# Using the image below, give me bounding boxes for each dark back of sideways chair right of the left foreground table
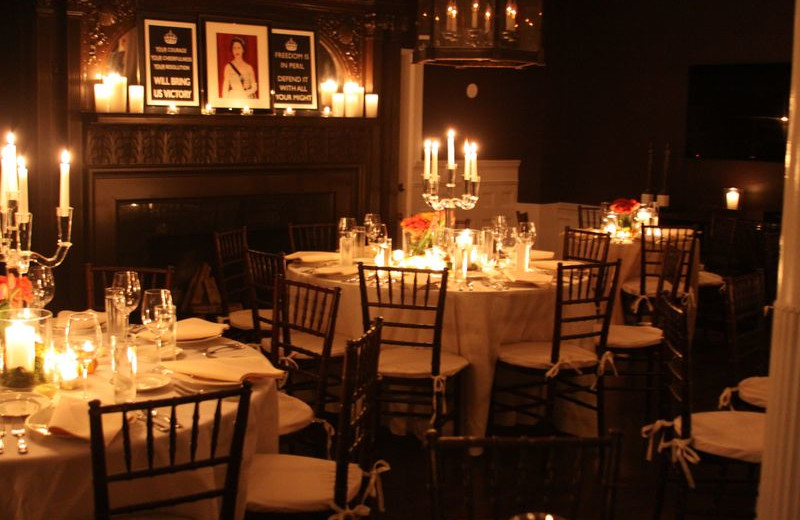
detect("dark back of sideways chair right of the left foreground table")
[334,318,383,507]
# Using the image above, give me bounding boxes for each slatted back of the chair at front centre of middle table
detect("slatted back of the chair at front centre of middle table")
[358,263,448,375]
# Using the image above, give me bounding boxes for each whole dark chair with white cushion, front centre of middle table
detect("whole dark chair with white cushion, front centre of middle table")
[358,262,469,432]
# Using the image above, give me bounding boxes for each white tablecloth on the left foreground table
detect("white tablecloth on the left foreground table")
[0,341,278,520]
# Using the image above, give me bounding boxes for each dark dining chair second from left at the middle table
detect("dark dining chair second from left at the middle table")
[241,249,286,349]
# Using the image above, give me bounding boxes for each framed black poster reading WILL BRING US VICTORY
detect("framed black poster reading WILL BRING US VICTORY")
[144,19,200,107]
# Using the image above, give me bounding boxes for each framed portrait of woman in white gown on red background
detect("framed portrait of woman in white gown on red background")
[204,20,271,108]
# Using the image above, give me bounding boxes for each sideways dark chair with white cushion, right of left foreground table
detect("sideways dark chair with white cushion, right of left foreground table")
[247,319,389,518]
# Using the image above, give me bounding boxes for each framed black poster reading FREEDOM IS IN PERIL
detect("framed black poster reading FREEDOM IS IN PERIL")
[270,29,317,109]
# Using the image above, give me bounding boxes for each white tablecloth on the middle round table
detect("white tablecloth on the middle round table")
[287,266,555,435]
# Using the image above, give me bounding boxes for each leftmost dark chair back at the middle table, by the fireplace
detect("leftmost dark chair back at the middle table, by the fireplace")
[214,226,247,315]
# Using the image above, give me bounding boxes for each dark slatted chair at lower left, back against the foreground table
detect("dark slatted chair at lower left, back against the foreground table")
[89,382,251,520]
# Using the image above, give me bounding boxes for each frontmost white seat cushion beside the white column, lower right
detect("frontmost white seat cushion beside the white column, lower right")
[674,411,766,463]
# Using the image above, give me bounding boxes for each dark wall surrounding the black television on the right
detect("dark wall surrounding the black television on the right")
[424,0,794,215]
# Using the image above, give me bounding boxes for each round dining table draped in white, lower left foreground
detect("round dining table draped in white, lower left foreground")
[0,338,278,520]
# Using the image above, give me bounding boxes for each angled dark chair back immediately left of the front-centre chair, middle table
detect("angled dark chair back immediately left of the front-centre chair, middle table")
[270,275,342,415]
